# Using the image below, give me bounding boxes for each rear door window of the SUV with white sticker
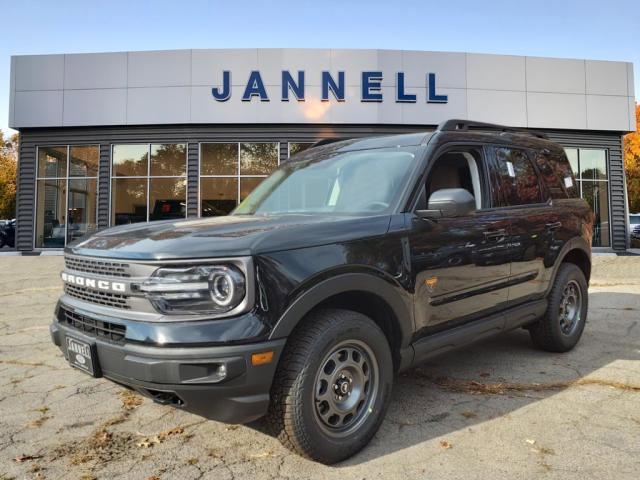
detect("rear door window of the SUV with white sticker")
[492,147,542,207]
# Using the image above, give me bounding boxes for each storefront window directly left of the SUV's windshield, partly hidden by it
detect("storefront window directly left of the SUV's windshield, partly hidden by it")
[200,142,280,217]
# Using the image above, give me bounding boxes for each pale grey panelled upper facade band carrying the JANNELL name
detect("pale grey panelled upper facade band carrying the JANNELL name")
[9,48,635,131]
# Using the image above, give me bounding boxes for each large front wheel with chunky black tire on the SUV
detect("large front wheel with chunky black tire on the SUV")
[266,309,394,464]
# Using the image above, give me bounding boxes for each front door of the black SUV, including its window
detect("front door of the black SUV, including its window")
[409,146,510,336]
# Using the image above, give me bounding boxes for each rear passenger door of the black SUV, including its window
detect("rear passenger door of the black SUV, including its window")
[489,146,561,305]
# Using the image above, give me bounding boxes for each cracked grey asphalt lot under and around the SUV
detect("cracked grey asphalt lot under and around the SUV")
[0,257,640,480]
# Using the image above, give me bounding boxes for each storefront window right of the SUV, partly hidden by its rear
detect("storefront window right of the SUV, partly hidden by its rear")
[565,148,611,247]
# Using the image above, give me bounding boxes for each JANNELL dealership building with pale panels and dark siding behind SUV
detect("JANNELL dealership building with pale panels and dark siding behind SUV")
[9,49,636,253]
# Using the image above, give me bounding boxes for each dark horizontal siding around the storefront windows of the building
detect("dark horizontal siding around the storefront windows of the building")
[17,124,627,250]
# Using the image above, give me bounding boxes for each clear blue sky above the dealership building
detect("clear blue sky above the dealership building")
[0,0,640,132]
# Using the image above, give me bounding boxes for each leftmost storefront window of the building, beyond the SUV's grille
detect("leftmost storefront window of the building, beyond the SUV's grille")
[35,145,100,248]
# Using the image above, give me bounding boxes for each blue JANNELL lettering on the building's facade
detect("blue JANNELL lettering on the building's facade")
[211,70,449,103]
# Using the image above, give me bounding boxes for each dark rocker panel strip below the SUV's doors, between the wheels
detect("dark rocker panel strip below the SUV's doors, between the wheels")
[412,299,547,365]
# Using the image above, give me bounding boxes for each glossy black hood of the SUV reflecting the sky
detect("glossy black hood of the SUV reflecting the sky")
[65,215,391,260]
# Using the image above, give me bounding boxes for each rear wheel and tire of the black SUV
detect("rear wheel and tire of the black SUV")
[529,263,589,352]
